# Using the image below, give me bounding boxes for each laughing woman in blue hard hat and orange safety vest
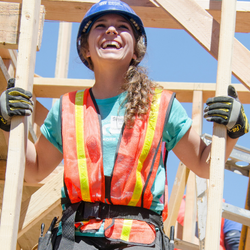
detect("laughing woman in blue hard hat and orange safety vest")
[1,0,248,250]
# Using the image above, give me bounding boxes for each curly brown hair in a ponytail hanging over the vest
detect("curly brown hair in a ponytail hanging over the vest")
[80,32,162,128]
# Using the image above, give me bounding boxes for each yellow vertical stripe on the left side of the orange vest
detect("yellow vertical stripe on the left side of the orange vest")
[75,91,91,201]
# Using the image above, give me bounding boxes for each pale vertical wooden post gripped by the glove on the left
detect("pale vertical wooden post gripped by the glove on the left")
[0,0,41,250]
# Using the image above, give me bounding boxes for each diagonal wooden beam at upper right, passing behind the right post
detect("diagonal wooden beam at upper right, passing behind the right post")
[156,0,250,90]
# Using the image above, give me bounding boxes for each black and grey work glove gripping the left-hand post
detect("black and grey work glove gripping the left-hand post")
[0,78,33,131]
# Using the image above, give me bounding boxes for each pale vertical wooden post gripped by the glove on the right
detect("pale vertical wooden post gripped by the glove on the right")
[205,0,236,250]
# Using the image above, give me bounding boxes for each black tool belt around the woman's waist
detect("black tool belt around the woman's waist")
[38,201,172,250]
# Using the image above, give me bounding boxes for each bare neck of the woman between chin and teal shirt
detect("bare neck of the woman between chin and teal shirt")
[92,62,127,99]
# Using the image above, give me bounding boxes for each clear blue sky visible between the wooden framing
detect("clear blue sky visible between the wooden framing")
[35,6,250,207]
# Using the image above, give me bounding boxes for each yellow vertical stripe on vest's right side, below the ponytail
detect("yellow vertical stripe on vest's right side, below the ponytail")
[128,89,162,206]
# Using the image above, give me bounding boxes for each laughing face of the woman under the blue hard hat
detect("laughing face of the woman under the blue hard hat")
[87,14,136,68]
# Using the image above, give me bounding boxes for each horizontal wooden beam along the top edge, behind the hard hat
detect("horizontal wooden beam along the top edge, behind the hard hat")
[1,0,250,33]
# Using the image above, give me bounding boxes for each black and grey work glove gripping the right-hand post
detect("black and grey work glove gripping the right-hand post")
[204,85,249,138]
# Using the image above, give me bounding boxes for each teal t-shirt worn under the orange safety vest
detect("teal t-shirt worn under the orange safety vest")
[41,92,192,236]
